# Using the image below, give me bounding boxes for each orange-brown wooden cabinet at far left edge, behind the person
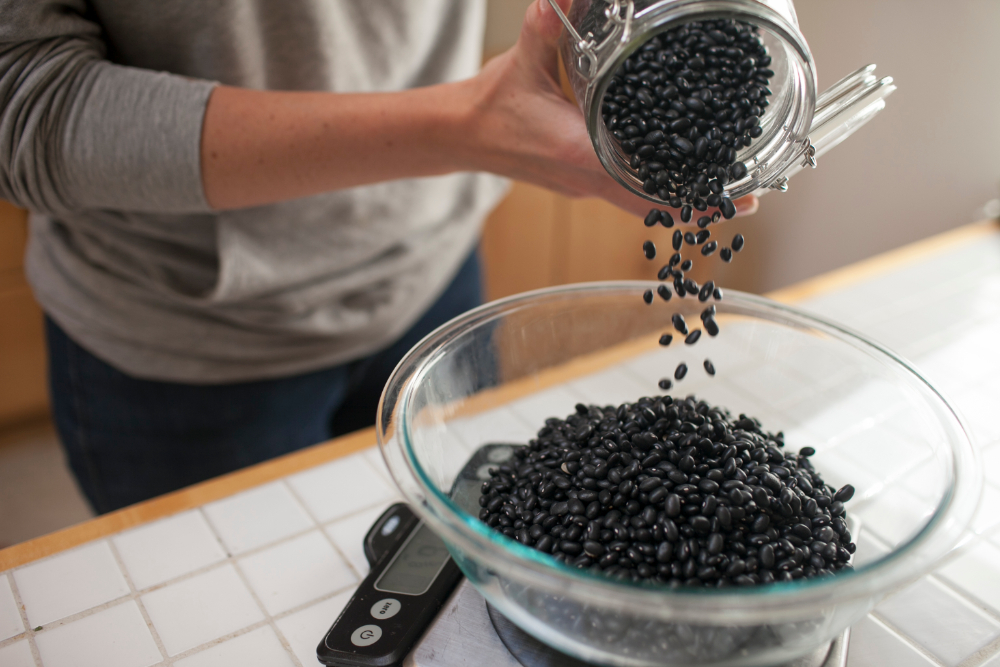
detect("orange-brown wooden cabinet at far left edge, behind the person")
[0,201,48,428]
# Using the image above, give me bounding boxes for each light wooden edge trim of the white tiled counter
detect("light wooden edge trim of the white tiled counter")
[0,221,1000,572]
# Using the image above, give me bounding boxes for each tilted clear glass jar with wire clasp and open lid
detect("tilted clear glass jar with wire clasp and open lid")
[549,0,896,205]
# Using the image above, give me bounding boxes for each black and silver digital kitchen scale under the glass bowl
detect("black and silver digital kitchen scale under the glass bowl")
[316,445,850,667]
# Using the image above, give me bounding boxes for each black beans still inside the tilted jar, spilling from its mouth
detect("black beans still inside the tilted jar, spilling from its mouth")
[601,19,774,222]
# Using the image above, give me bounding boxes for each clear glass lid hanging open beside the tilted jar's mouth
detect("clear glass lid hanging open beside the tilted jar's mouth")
[758,65,896,194]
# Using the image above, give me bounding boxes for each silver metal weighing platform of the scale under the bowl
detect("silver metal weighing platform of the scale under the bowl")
[403,579,850,667]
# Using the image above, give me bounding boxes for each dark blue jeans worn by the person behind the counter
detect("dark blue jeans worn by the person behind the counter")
[45,253,482,513]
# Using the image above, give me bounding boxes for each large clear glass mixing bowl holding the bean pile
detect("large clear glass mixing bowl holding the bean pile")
[378,282,980,666]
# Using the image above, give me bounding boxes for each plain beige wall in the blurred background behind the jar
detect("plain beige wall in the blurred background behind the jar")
[487,0,1000,291]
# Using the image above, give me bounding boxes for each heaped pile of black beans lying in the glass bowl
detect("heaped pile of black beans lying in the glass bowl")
[479,396,855,587]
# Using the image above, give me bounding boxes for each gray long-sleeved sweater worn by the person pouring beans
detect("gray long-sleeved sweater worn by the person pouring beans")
[0,0,505,383]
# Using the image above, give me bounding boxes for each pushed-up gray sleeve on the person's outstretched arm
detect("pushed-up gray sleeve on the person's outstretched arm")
[0,0,214,215]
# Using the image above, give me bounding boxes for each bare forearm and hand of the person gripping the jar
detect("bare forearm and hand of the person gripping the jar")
[201,0,756,215]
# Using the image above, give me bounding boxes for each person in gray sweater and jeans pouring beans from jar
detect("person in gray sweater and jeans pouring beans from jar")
[0,0,755,512]
